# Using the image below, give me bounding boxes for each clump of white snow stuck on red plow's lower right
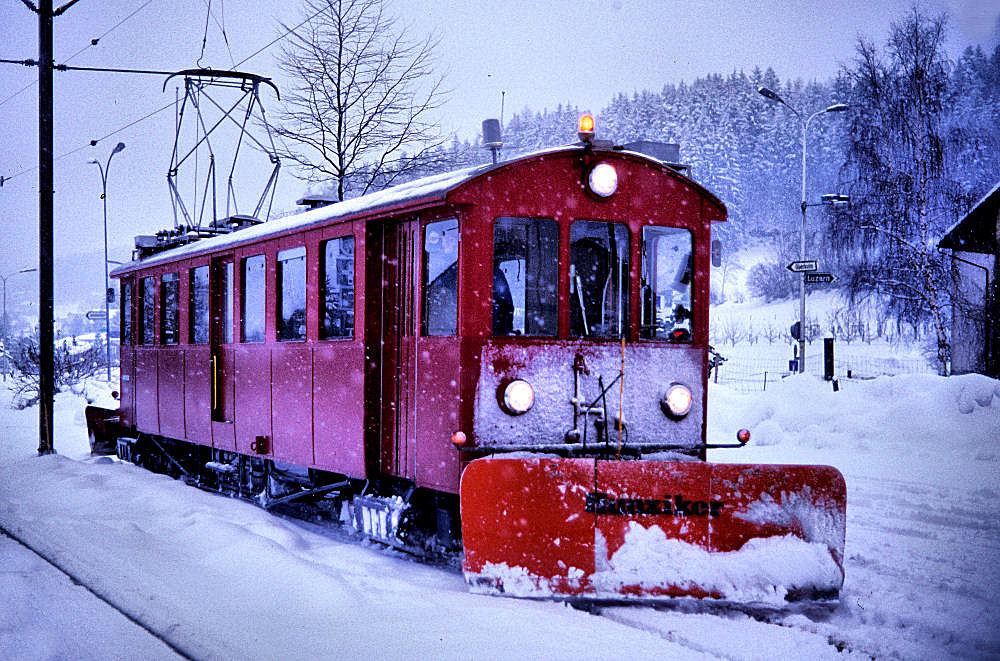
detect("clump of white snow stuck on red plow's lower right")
[592,521,843,605]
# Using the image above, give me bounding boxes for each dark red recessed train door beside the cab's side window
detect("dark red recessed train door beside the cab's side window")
[366,221,419,479]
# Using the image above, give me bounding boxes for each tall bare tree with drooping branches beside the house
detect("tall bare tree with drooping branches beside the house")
[830,8,967,374]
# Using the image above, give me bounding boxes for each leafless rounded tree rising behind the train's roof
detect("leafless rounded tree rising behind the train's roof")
[276,0,445,200]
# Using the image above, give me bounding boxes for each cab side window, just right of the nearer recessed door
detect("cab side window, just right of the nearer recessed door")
[422,218,458,335]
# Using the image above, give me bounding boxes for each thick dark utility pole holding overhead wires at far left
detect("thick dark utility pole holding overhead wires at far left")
[21,0,79,454]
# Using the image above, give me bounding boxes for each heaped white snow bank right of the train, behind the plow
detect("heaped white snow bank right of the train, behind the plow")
[708,374,1000,486]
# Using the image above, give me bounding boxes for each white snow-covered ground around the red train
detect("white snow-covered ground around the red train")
[0,366,1000,659]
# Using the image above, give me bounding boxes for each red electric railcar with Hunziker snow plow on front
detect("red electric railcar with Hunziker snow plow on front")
[103,124,844,598]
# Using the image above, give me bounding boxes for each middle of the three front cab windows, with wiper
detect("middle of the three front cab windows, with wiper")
[569,220,629,337]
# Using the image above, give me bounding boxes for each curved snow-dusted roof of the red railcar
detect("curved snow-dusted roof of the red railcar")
[110,145,725,276]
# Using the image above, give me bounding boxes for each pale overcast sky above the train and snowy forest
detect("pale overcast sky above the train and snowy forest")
[0,0,1000,314]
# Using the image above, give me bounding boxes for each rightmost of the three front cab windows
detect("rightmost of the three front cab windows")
[641,227,693,342]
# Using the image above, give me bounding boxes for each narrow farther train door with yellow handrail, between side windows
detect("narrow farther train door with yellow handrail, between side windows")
[209,255,236,450]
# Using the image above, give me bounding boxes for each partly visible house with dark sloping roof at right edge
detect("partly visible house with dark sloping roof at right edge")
[938,184,1000,378]
